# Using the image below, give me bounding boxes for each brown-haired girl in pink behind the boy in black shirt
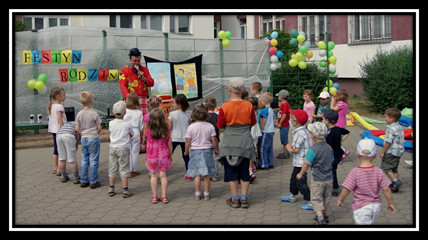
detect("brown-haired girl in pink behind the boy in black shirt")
[330,88,349,163]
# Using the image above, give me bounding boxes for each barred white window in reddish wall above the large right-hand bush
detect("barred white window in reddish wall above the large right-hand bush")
[348,15,391,44]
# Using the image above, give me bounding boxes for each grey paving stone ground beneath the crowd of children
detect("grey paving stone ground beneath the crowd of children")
[10,123,419,231]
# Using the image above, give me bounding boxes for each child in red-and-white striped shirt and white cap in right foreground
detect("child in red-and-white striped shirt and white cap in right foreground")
[337,138,395,225]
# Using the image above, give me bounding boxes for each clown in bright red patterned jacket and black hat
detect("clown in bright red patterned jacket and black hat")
[119,48,154,153]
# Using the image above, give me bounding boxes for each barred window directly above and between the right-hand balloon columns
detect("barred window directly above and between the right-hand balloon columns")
[299,15,331,46]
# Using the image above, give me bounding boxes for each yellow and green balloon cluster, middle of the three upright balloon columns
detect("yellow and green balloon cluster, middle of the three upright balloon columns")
[288,29,314,69]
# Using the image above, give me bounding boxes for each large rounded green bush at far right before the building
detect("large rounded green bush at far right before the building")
[358,45,415,113]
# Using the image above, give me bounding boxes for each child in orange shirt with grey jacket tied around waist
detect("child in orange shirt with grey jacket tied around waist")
[217,77,257,208]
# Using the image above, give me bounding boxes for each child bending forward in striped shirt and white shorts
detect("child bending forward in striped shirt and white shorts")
[56,122,80,184]
